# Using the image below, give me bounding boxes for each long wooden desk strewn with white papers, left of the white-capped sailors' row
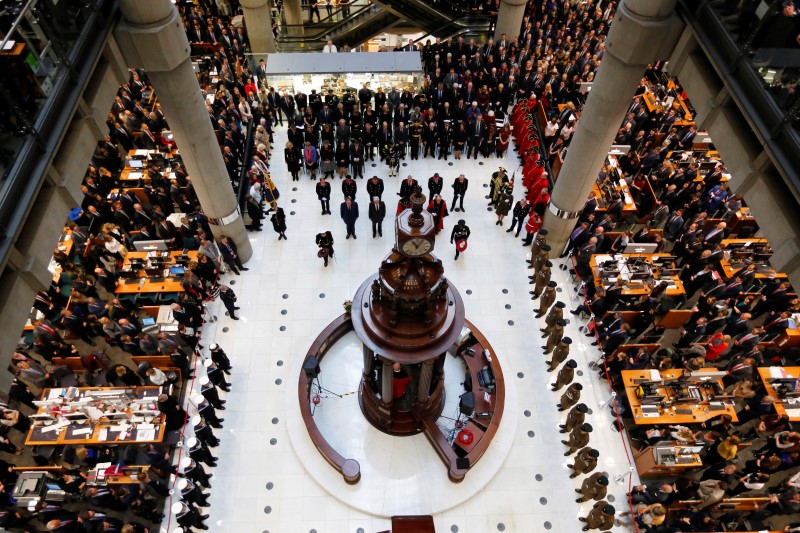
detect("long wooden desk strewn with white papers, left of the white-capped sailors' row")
[25,386,166,446]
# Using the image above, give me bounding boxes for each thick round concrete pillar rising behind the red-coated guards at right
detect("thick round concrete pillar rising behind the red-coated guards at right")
[540,0,683,253]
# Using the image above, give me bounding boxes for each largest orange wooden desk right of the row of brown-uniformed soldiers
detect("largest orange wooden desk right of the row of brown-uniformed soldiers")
[622,368,739,425]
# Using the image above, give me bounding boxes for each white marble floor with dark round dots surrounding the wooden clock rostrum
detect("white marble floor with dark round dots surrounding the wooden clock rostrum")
[169,124,629,533]
